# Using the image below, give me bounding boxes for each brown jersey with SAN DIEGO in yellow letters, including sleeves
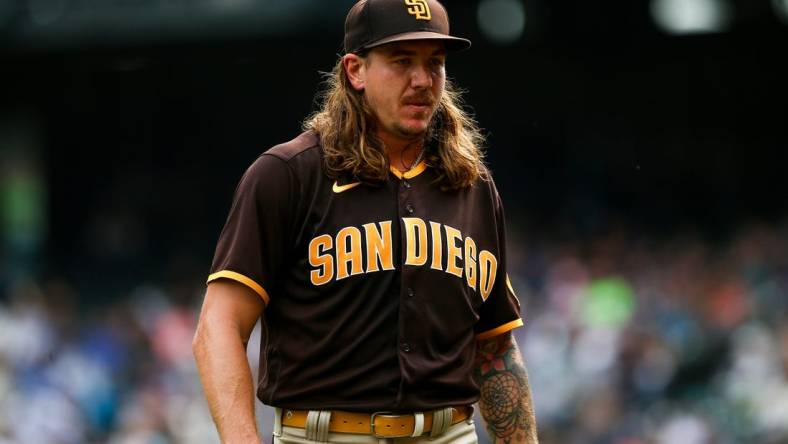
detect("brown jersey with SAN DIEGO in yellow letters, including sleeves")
[208,132,522,412]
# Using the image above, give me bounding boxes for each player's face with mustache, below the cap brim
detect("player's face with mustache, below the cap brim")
[343,40,446,140]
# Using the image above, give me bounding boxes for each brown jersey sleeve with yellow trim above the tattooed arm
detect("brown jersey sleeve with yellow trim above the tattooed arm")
[474,179,523,339]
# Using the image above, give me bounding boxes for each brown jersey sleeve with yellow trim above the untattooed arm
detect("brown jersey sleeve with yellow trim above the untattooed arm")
[207,154,295,305]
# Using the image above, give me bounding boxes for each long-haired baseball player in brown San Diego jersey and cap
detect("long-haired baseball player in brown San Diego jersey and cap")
[194,0,536,443]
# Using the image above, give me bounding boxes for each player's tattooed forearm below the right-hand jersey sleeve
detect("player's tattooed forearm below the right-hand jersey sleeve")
[474,332,538,444]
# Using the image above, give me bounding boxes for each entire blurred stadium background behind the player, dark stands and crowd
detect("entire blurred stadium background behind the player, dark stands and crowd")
[0,0,788,444]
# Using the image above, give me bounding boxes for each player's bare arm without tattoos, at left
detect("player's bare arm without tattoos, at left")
[192,280,264,444]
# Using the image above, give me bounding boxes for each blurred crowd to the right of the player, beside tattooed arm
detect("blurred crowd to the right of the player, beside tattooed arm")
[513,224,788,444]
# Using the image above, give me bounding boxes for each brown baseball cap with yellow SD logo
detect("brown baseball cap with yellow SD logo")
[345,0,471,53]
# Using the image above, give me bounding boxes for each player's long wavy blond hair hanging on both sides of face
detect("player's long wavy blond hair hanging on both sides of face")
[303,58,487,190]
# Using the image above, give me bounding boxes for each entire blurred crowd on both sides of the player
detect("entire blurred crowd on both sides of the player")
[0,220,788,444]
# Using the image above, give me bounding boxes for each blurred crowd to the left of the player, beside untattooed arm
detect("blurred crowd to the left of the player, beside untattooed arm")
[0,281,218,444]
